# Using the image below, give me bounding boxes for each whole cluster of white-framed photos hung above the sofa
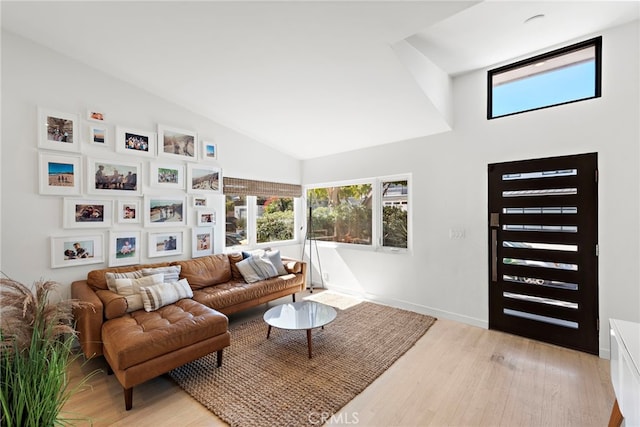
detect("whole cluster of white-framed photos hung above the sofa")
[37,107,222,268]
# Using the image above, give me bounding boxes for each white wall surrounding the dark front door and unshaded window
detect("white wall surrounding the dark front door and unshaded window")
[303,22,640,356]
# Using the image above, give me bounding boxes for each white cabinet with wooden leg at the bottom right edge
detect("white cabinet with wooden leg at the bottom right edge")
[609,319,640,427]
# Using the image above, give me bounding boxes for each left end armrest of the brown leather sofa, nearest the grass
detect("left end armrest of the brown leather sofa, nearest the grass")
[71,280,104,358]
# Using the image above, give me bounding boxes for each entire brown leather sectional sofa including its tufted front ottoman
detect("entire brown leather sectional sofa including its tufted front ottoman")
[71,253,307,410]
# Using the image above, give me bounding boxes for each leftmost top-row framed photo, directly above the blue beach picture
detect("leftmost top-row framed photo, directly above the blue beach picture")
[38,107,80,151]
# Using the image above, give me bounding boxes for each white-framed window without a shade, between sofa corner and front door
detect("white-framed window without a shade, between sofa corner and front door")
[307,176,409,250]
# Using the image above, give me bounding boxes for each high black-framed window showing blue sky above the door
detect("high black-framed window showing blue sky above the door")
[487,37,602,119]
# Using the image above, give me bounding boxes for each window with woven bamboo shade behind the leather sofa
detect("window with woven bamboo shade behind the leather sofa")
[224,177,302,251]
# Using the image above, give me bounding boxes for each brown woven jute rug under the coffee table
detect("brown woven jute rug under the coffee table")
[170,291,436,427]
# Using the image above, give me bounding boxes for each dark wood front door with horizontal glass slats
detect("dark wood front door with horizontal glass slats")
[488,153,599,354]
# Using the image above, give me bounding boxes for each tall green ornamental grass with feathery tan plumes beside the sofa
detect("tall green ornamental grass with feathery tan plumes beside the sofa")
[0,277,95,427]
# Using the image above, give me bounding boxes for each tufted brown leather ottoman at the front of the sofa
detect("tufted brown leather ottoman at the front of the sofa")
[102,299,230,410]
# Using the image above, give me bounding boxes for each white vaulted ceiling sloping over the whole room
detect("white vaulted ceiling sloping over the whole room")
[1,1,640,159]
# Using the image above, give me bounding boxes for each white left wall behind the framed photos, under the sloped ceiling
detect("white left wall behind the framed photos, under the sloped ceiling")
[0,32,301,297]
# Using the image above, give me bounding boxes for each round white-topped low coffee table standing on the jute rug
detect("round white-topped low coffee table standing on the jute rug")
[264,301,336,359]
